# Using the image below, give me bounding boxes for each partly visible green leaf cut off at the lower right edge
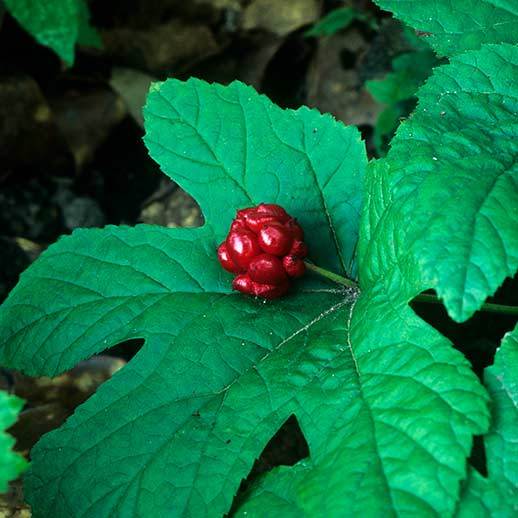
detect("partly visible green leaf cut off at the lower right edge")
[457,327,518,518]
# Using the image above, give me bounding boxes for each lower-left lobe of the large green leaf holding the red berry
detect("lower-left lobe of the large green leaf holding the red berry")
[26,286,345,517]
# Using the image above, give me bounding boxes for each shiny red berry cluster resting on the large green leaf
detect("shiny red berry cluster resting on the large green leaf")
[218,203,307,299]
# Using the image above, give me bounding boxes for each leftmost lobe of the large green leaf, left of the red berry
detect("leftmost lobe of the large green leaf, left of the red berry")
[0,225,230,376]
